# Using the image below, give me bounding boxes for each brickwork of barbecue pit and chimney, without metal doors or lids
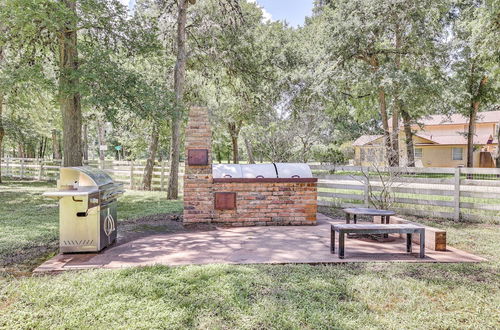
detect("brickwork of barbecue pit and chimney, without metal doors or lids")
[184,107,317,226]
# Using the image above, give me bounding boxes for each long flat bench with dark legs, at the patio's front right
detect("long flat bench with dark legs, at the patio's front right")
[330,224,425,259]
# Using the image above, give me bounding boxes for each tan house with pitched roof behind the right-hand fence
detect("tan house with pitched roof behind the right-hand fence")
[353,111,500,167]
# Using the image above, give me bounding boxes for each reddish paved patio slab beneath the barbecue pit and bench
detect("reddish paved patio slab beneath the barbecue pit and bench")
[35,214,486,273]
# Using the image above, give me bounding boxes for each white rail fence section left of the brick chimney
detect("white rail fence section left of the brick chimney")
[1,158,184,191]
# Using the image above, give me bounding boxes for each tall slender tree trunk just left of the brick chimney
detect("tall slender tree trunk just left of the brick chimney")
[167,0,188,199]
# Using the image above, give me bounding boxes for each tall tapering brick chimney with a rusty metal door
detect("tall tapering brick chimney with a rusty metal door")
[184,107,214,223]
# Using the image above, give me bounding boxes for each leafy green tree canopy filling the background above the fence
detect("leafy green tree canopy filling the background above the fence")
[0,0,500,184]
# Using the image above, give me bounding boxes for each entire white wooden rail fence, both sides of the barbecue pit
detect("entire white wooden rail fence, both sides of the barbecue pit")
[1,158,500,223]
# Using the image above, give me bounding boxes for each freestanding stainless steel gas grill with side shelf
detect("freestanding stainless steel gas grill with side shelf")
[43,166,124,253]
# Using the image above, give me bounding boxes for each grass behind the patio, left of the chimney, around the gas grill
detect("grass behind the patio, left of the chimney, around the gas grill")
[0,181,182,268]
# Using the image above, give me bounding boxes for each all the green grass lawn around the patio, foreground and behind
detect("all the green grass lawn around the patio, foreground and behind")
[0,182,500,329]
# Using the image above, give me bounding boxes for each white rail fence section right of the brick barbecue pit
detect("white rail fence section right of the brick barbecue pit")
[311,165,500,223]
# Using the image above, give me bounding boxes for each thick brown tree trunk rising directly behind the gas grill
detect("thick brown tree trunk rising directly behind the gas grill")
[59,0,82,166]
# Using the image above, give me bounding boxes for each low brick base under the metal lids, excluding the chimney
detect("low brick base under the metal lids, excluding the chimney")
[213,182,317,226]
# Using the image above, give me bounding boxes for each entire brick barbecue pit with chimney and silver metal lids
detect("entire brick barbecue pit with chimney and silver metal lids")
[184,107,317,226]
